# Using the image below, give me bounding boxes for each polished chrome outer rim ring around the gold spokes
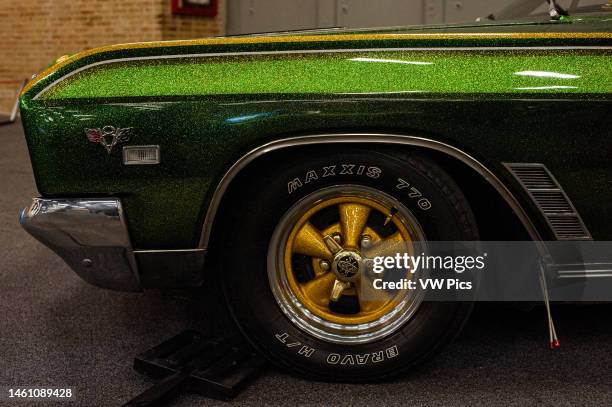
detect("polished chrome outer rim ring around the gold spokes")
[267,184,426,344]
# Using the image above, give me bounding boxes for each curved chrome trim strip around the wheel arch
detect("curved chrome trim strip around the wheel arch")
[198,133,548,252]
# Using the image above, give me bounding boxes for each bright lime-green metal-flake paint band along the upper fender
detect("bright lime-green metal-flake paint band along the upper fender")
[38,51,612,100]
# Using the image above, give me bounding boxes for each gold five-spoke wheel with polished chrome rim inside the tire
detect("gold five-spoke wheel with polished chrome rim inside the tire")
[268,185,425,343]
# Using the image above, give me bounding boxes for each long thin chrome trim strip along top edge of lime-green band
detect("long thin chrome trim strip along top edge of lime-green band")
[32,45,612,100]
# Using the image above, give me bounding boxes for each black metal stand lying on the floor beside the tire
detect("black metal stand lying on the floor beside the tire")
[124,331,265,407]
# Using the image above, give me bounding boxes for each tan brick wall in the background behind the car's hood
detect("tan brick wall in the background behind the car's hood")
[0,0,226,113]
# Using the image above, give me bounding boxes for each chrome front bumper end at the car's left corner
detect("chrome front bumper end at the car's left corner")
[19,198,141,291]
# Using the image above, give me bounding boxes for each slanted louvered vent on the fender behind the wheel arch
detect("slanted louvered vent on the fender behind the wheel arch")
[504,163,591,240]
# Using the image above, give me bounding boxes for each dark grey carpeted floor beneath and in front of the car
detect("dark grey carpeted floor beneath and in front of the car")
[0,122,612,406]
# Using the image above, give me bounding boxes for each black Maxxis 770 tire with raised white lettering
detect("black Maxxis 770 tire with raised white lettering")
[221,149,478,382]
